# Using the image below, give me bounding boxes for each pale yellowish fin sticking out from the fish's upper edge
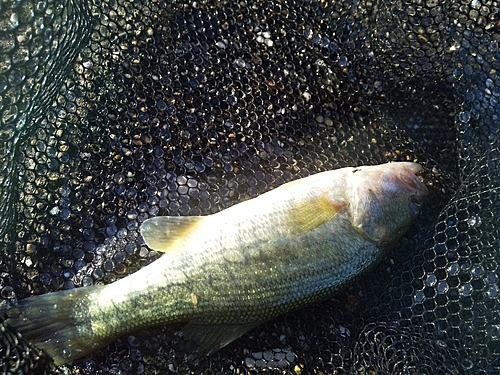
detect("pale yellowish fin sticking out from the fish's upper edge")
[141,216,206,252]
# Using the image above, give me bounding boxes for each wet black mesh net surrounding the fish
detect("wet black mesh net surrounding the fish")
[0,0,500,374]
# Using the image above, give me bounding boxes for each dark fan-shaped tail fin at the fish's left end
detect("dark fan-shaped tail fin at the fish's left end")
[0,286,111,366]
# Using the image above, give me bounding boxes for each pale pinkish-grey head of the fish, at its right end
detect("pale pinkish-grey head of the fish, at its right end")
[350,162,428,248]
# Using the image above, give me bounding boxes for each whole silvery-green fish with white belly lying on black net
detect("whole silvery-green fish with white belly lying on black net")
[0,162,428,365]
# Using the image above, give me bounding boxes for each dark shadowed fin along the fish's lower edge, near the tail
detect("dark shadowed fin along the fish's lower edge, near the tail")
[182,323,260,360]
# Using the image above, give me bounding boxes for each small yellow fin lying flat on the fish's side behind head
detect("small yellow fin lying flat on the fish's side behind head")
[286,193,349,235]
